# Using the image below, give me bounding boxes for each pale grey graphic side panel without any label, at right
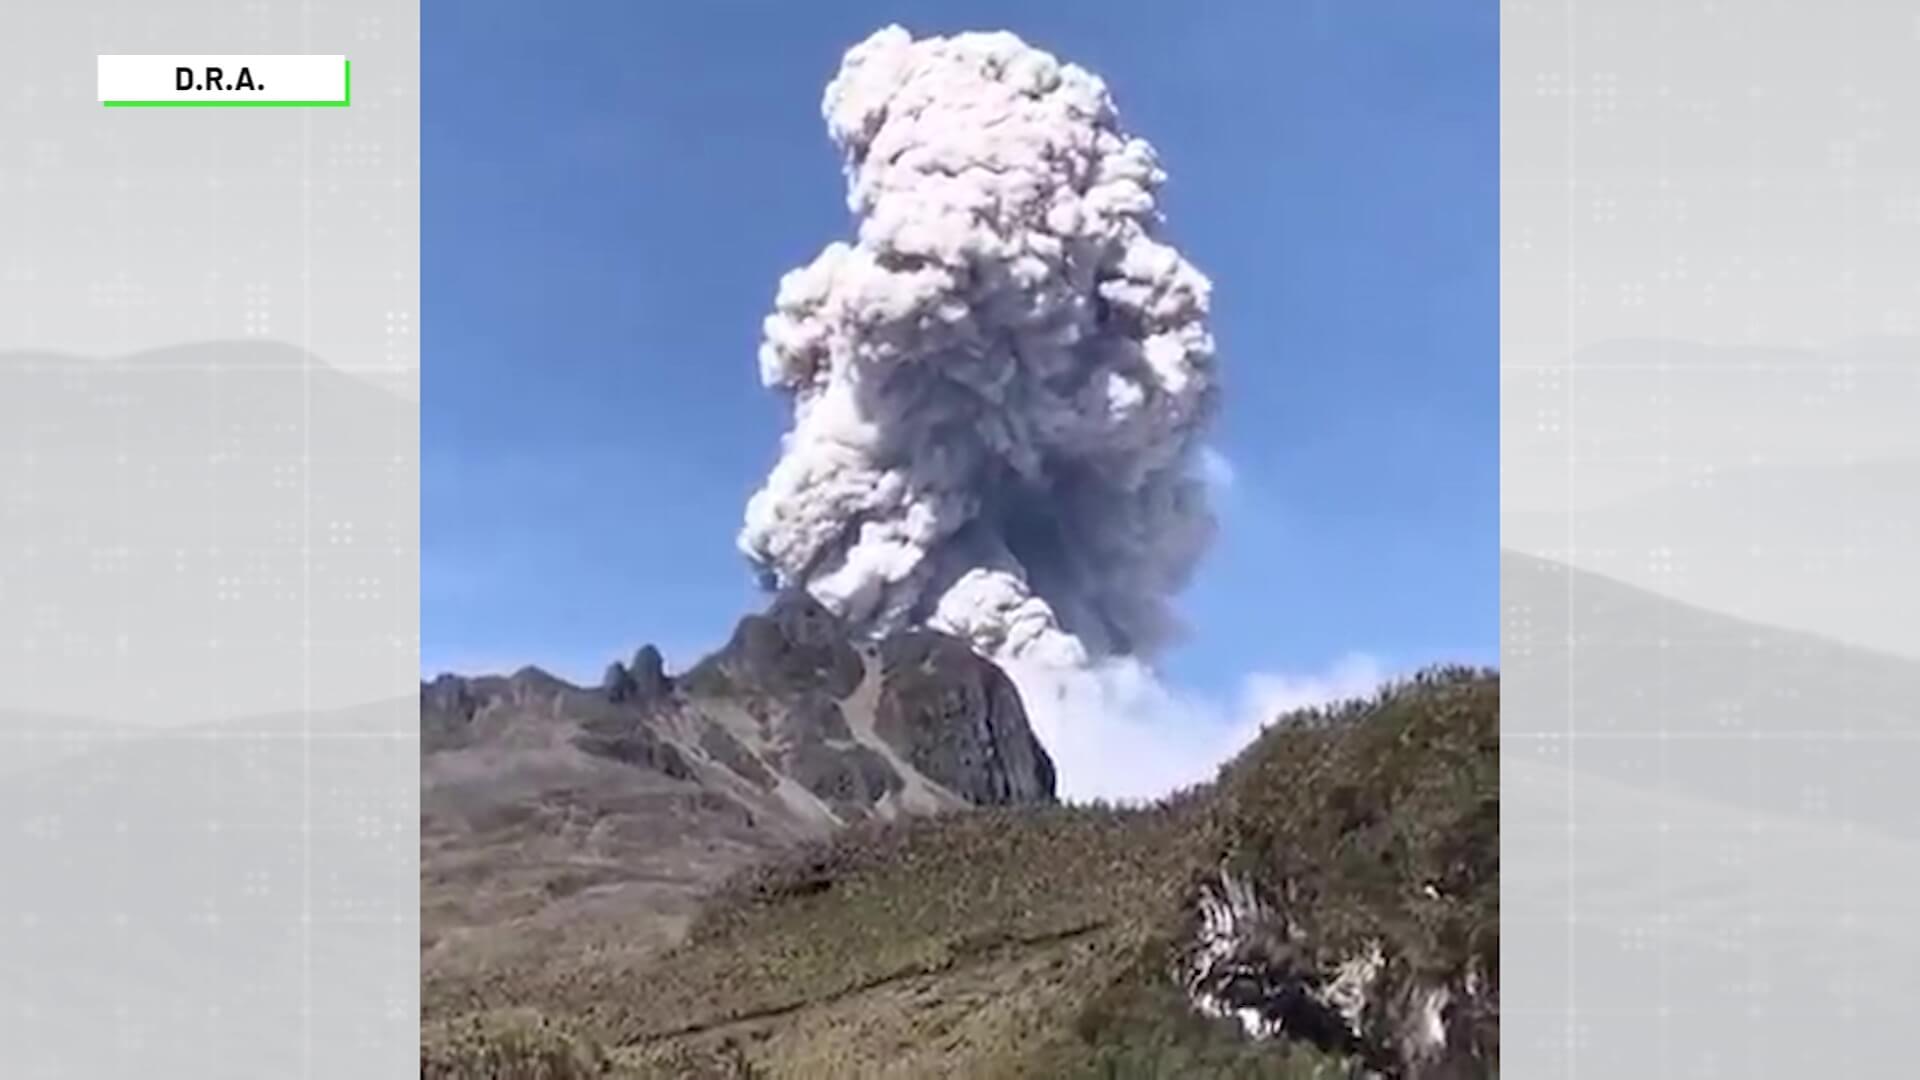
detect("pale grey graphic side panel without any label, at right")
[1501,0,1920,1078]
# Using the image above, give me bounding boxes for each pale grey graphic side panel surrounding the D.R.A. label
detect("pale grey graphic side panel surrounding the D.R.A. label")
[0,0,419,1078]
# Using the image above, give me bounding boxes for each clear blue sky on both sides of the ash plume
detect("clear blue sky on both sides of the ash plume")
[420,0,1500,694]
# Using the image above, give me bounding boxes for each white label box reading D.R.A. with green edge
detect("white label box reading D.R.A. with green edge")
[100,54,353,108]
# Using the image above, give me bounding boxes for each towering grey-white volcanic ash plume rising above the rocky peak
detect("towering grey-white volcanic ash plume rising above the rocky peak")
[739,27,1215,667]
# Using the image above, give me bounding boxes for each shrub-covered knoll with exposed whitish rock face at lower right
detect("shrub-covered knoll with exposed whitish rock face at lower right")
[1175,669,1500,1080]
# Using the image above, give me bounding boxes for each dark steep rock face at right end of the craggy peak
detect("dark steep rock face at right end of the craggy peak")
[874,630,1054,805]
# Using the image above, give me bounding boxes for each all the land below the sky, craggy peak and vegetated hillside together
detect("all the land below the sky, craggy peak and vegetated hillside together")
[422,598,1500,1080]
